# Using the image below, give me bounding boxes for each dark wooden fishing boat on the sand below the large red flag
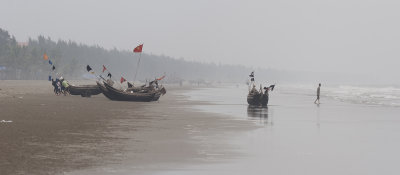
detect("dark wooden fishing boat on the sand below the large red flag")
[103,82,156,102]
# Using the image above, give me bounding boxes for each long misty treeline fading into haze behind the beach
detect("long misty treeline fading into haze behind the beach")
[0,28,372,84]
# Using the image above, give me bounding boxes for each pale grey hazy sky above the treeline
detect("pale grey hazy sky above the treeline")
[0,0,400,77]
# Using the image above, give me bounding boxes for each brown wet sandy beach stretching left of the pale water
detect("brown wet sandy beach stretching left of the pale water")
[0,81,254,174]
